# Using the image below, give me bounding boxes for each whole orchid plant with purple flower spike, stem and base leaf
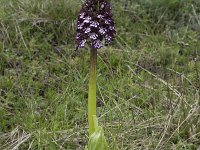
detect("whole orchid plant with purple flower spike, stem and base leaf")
[76,0,116,150]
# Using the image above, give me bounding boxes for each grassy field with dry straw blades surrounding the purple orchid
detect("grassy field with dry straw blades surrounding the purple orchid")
[0,0,200,150]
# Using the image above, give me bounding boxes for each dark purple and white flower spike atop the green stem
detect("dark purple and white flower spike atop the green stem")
[76,0,116,49]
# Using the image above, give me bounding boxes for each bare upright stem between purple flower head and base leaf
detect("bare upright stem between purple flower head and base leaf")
[88,49,97,136]
